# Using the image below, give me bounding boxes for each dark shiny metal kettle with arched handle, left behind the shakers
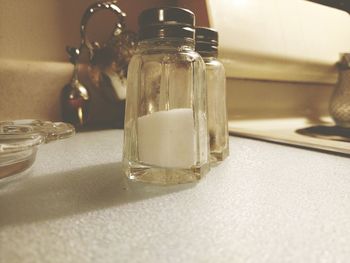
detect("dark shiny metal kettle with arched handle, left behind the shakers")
[61,1,137,128]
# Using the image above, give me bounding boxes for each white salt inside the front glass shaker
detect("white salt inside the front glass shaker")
[137,109,196,168]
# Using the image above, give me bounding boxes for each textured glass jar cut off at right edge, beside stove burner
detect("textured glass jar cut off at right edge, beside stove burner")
[329,53,350,128]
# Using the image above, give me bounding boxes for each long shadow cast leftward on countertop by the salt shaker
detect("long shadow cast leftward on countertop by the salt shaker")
[0,163,195,228]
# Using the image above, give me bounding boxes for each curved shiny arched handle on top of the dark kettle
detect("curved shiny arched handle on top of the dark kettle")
[80,1,126,52]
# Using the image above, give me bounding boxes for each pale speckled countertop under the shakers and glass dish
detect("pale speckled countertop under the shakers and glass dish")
[0,130,350,263]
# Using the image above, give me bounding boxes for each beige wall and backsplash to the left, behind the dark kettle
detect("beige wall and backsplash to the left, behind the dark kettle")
[0,0,173,120]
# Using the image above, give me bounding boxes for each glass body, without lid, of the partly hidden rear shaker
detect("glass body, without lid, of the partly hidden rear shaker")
[200,52,229,163]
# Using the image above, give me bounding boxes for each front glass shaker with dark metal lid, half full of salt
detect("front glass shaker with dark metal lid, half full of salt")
[123,7,210,184]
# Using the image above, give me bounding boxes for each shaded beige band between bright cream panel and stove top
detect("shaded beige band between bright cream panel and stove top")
[227,78,334,121]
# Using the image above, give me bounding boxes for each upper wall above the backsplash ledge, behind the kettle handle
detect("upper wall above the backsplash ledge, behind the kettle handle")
[0,0,172,62]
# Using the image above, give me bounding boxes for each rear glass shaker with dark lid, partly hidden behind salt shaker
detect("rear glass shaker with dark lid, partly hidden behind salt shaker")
[196,27,229,163]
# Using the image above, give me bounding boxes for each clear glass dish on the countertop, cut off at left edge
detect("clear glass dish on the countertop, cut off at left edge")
[0,120,75,183]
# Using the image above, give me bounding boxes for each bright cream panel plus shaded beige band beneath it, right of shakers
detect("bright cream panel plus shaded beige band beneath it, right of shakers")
[206,0,350,120]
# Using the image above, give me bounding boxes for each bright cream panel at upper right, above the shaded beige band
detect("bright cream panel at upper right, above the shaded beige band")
[207,0,350,83]
